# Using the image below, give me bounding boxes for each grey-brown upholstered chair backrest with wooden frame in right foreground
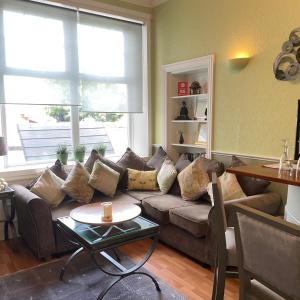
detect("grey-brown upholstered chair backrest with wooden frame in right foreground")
[234,204,300,300]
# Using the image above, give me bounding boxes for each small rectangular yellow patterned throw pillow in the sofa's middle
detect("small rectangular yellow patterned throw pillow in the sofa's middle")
[127,169,157,191]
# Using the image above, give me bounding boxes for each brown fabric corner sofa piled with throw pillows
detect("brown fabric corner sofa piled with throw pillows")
[13,185,281,265]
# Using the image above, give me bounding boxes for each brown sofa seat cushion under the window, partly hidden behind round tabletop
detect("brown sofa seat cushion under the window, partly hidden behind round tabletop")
[51,192,141,222]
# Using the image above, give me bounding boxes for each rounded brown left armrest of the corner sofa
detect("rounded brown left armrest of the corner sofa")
[12,185,56,258]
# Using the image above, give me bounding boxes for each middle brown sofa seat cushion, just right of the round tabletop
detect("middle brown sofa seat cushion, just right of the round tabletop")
[142,194,192,224]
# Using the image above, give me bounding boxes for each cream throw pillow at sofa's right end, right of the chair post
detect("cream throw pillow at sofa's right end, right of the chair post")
[218,172,246,201]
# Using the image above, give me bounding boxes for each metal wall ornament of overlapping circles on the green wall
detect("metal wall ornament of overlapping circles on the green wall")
[273,27,300,81]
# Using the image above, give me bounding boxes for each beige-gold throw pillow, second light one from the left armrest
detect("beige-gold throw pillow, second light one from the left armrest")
[62,162,94,203]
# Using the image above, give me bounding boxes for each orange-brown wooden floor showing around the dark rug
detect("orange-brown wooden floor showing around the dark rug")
[0,240,239,300]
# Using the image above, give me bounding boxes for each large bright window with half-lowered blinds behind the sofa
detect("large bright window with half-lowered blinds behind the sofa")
[0,0,148,166]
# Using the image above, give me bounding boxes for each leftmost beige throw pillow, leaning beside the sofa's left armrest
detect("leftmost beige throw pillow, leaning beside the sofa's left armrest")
[30,168,65,207]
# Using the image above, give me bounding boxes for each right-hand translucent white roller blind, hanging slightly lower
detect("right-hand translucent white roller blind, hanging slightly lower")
[77,13,143,113]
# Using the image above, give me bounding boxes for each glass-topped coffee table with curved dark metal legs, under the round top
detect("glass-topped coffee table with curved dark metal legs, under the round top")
[57,216,160,300]
